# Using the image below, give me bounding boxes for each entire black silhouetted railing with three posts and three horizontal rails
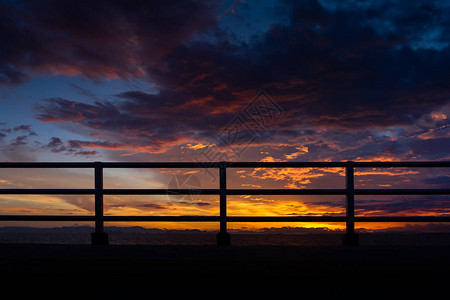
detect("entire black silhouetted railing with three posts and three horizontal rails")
[0,161,450,245]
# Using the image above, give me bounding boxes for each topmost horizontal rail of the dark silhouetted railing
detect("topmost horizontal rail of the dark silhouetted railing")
[0,161,450,168]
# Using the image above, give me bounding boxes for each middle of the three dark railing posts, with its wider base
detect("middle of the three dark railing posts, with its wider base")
[217,162,231,246]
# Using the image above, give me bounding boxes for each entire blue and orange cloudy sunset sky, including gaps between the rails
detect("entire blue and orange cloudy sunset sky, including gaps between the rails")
[0,0,450,229]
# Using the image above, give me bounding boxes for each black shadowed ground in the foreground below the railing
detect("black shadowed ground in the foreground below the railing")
[0,234,450,299]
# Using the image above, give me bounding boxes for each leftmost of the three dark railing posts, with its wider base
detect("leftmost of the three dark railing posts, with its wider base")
[91,161,108,245]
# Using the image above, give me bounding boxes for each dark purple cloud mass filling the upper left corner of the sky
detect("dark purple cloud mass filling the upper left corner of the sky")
[0,0,215,86]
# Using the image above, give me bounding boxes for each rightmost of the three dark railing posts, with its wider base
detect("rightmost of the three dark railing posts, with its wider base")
[343,161,359,246]
